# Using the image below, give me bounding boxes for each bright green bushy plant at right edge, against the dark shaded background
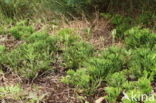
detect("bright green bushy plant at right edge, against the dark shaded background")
[125,27,156,48]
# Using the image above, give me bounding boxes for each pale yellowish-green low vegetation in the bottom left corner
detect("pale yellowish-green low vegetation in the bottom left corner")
[0,84,45,103]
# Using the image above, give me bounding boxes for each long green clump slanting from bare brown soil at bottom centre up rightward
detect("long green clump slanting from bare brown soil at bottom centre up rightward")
[63,47,129,93]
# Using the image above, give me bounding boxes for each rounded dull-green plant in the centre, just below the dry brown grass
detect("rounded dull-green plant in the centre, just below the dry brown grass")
[63,42,94,69]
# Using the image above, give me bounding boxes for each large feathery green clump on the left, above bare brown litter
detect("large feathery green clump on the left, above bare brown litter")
[1,33,57,79]
